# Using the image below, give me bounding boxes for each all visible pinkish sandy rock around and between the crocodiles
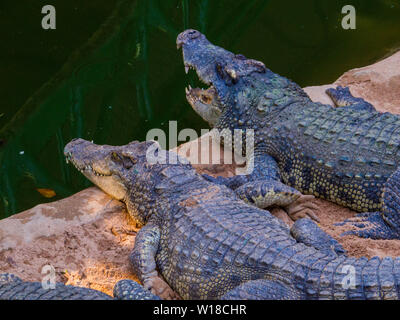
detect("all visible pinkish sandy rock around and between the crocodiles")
[0,52,400,294]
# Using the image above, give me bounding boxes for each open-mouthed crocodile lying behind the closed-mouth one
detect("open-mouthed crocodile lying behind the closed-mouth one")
[176,29,400,239]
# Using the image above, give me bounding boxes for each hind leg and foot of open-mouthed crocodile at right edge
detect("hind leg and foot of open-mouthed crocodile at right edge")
[336,168,400,240]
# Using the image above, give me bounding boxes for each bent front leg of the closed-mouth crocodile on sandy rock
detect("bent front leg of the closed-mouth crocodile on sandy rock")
[129,222,179,299]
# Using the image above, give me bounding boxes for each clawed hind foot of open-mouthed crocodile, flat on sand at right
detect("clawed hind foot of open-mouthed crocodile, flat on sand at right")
[335,212,400,240]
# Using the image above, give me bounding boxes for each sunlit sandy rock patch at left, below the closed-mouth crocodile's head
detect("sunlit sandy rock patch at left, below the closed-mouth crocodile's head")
[0,187,138,294]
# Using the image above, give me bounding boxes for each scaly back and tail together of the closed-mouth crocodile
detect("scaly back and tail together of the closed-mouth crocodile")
[156,178,400,299]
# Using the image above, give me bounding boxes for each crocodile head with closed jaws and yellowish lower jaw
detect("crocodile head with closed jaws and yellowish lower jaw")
[64,139,159,225]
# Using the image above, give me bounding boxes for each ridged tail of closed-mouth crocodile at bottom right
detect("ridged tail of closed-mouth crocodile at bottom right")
[292,252,400,300]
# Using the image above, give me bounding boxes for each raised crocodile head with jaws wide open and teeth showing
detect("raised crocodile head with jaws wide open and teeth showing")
[176,29,305,128]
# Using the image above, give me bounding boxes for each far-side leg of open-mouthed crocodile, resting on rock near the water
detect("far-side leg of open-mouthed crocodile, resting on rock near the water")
[325,86,376,112]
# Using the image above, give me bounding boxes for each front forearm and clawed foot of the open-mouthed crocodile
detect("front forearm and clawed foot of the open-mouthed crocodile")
[235,179,319,221]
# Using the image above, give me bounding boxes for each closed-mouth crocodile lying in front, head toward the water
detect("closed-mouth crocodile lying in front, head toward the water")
[59,138,400,299]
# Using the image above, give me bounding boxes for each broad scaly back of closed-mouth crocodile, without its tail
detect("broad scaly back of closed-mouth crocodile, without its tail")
[156,185,296,299]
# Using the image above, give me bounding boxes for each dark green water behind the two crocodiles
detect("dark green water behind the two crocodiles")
[0,0,400,218]
